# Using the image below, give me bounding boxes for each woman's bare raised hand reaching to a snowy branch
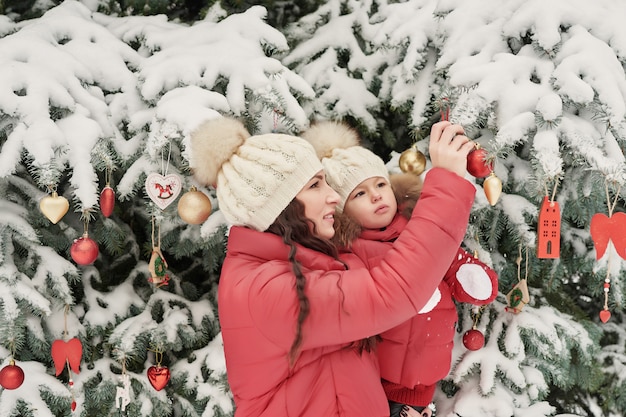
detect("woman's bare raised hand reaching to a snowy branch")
[428,121,474,177]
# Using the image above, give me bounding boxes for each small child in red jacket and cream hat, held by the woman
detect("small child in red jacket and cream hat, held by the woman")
[303,122,498,417]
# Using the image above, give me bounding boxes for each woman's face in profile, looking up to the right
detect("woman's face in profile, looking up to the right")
[296,171,339,239]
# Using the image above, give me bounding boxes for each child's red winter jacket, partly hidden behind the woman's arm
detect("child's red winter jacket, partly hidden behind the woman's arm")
[352,214,498,407]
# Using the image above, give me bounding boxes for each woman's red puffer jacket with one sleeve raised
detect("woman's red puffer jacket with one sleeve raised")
[218,169,475,417]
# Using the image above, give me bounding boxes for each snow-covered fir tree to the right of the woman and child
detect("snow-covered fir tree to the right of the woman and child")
[284,0,626,417]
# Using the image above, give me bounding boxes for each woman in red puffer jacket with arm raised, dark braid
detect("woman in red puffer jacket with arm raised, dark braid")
[191,118,475,417]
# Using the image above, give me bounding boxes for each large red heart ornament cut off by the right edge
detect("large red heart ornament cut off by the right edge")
[589,212,626,260]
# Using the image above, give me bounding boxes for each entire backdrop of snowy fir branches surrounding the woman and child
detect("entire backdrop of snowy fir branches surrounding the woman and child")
[0,0,626,417]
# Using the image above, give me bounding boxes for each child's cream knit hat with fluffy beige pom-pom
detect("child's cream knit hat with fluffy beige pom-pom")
[301,121,389,212]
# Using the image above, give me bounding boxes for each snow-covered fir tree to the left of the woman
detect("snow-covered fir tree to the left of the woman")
[0,1,313,417]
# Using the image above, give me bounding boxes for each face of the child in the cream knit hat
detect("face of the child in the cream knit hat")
[343,177,398,229]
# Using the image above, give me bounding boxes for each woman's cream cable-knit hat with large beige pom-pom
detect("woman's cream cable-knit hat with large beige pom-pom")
[190,118,323,231]
